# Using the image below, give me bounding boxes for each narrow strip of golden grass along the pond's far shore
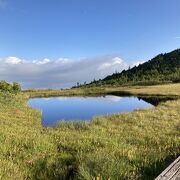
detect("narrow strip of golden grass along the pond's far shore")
[23,83,180,97]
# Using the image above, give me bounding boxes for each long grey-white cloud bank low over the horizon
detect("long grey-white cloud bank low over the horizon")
[0,56,128,89]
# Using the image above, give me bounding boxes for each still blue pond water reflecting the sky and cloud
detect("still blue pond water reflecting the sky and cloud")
[28,95,153,127]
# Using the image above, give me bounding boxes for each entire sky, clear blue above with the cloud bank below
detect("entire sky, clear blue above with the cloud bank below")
[0,0,180,89]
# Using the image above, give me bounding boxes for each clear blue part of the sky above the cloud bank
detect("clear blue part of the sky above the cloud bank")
[0,0,180,60]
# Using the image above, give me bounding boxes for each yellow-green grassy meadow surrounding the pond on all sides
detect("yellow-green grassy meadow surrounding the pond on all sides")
[0,84,180,180]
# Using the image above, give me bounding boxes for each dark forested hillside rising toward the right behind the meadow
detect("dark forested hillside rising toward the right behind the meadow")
[89,49,180,86]
